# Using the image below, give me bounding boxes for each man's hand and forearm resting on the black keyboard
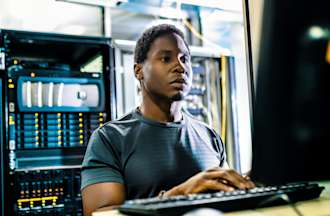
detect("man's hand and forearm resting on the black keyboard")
[164,167,255,196]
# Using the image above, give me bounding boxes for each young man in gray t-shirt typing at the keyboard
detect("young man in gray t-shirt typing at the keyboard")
[82,24,254,215]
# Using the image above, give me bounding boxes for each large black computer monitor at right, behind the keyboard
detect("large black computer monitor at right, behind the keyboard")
[252,0,330,184]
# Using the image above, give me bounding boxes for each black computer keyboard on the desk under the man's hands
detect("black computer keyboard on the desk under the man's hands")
[119,183,324,216]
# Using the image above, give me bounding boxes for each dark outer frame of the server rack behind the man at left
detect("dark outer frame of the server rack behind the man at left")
[0,29,117,215]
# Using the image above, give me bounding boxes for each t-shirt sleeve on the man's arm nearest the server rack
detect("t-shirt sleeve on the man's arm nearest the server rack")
[81,128,124,189]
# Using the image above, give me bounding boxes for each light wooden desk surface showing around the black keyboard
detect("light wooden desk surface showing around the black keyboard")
[93,181,330,216]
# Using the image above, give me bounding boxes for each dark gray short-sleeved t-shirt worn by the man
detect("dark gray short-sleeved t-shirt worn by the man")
[81,110,226,199]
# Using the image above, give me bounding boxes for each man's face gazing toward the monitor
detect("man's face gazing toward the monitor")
[140,33,192,101]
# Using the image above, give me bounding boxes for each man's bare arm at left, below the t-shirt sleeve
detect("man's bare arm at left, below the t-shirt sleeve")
[81,182,125,216]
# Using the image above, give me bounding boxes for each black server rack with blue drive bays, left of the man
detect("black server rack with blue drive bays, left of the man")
[0,30,116,215]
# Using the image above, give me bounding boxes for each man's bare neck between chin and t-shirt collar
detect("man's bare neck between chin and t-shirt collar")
[139,95,182,122]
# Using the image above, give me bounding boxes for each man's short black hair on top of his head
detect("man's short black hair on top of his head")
[134,24,189,63]
